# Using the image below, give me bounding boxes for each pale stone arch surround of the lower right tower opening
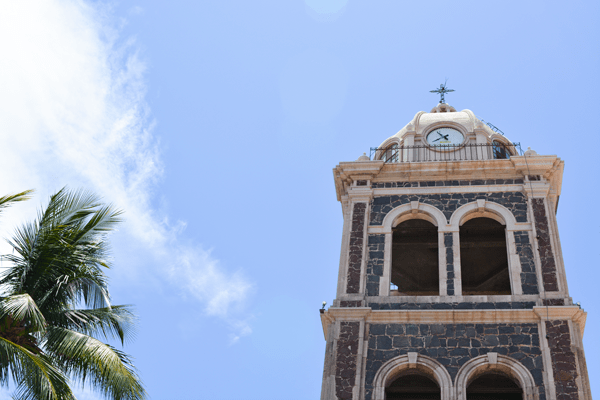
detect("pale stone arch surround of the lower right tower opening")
[455,353,538,400]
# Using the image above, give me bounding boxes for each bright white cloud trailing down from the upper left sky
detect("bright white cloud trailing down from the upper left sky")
[0,0,252,337]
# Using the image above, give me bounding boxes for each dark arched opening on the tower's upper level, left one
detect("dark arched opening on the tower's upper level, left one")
[391,219,439,296]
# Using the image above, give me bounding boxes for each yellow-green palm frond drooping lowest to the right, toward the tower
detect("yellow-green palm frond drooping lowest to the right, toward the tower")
[45,327,147,400]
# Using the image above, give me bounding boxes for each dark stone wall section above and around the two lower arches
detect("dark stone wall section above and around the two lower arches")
[365,324,548,400]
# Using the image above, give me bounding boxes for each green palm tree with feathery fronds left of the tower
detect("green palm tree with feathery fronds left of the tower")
[0,188,146,400]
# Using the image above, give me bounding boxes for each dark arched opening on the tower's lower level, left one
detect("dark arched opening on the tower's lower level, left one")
[385,370,441,400]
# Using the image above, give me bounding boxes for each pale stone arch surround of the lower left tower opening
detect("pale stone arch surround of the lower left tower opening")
[372,353,454,400]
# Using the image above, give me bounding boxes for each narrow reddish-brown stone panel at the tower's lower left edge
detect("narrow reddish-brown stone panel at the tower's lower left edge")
[335,322,360,400]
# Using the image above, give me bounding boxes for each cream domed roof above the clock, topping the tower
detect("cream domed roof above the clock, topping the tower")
[379,103,510,148]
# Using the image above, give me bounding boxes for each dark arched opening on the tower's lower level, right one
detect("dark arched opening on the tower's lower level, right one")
[467,372,523,400]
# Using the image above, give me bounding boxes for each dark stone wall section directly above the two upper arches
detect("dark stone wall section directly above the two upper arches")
[369,192,527,225]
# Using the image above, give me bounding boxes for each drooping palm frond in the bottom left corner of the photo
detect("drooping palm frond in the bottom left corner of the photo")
[0,337,75,400]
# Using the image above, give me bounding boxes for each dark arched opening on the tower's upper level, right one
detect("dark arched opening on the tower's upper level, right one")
[460,218,511,295]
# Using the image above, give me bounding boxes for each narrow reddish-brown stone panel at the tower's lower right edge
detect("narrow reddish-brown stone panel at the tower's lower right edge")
[546,320,579,400]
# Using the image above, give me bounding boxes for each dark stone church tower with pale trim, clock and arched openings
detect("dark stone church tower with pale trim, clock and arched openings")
[321,94,592,400]
